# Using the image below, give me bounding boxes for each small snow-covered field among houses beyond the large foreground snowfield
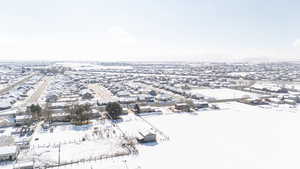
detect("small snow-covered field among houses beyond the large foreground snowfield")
[190,88,260,100]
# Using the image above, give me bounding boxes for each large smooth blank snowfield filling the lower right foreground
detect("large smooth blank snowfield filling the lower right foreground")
[47,103,300,169]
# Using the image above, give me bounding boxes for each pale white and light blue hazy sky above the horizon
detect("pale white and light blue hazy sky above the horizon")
[0,0,300,61]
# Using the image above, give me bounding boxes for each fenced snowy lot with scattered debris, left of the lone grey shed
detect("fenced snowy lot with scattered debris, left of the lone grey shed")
[20,121,128,164]
